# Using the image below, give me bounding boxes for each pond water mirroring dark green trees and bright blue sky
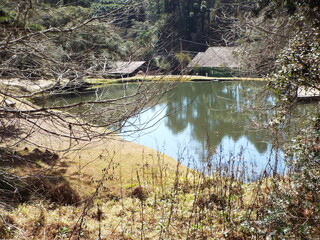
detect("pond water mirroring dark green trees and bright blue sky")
[125,82,282,175]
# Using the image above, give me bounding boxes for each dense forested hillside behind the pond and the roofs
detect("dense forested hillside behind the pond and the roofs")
[0,0,312,78]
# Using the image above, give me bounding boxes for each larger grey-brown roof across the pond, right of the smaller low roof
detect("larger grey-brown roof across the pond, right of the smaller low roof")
[188,47,240,68]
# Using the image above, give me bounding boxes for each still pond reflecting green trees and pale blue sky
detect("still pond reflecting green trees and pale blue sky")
[41,81,316,177]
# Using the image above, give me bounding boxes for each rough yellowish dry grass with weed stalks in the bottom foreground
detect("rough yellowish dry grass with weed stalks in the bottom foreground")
[1,166,272,239]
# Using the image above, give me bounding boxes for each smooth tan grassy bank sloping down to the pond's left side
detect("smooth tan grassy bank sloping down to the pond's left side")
[0,89,182,197]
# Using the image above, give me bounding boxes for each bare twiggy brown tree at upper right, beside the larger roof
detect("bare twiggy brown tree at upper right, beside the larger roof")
[235,0,319,76]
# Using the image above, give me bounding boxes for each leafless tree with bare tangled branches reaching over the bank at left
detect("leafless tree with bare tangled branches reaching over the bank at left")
[0,0,172,208]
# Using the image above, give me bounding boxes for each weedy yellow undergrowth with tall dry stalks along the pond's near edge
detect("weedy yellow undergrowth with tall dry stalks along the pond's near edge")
[0,149,300,239]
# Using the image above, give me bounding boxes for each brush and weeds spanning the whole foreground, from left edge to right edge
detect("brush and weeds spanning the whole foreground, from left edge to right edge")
[0,130,320,239]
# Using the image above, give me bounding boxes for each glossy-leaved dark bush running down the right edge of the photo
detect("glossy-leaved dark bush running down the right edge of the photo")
[248,1,320,239]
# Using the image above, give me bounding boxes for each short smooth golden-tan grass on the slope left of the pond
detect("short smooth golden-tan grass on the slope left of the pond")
[3,116,181,196]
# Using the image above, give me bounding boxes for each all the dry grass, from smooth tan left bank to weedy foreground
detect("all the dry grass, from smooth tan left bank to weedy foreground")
[0,101,264,239]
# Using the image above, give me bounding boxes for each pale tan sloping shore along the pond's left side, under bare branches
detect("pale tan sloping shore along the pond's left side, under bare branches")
[0,79,187,197]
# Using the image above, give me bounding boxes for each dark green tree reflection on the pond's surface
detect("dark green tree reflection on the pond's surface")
[165,82,270,158]
